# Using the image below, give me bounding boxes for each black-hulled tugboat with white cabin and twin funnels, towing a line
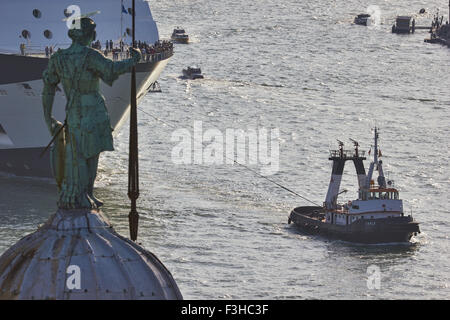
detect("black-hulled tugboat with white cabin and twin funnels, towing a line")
[288,128,420,244]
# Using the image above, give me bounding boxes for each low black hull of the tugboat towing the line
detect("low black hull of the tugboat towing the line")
[289,207,420,244]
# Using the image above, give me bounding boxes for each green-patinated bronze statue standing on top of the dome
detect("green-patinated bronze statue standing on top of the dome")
[42,18,141,209]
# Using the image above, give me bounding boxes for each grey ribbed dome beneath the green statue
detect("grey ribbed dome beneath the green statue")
[0,210,182,300]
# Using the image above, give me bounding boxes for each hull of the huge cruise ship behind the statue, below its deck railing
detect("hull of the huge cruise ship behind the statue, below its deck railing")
[0,55,169,177]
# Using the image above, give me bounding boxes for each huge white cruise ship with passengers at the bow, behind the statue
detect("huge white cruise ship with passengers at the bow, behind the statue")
[0,0,173,177]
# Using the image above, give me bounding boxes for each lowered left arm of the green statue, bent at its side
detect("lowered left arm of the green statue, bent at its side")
[42,57,62,135]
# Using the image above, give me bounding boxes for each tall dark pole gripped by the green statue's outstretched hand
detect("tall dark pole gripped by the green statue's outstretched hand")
[128,0,139,241]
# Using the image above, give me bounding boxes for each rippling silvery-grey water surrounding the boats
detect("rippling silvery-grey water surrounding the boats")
[0,0,450,299]
